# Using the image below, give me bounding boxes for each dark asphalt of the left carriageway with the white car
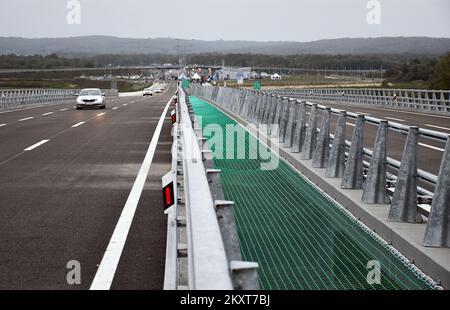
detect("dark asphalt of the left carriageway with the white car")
[0,86,175,289]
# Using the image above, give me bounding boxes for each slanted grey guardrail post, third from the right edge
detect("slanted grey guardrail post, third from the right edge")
[361,120,389,203]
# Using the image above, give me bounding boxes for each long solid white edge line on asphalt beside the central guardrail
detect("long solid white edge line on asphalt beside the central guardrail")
[89,100,171,290]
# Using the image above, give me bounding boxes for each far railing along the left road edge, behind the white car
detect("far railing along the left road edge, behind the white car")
[0,88,118,111]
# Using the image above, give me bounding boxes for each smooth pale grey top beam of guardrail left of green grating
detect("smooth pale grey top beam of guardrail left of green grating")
[179,88,233,290]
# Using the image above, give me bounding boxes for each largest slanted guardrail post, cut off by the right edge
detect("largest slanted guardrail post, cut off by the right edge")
[423,136,450,248]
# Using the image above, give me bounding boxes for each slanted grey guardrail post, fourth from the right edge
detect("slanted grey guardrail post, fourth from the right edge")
[341,115,365,189]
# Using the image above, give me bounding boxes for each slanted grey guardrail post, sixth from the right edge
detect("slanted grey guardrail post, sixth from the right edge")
[312,107,331,168]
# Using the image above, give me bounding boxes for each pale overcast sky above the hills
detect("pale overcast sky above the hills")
[0,0,450,41]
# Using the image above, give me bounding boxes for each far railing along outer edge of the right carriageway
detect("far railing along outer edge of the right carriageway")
[267,88,450,115]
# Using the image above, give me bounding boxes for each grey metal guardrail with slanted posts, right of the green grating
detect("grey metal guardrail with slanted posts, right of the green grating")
[191,86,450,247]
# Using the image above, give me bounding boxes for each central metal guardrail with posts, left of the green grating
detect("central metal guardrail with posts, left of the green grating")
[164,88,259,290]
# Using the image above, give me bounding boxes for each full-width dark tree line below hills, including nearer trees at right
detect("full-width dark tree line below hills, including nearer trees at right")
[0,53,450,89]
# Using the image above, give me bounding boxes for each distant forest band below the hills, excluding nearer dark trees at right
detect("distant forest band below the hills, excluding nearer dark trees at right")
[0,53,434,70]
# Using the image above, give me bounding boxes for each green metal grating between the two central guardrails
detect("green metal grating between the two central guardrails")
[190,96,436,290]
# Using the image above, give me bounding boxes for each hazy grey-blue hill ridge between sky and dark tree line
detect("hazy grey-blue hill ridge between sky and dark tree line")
[0,36,450,56]
